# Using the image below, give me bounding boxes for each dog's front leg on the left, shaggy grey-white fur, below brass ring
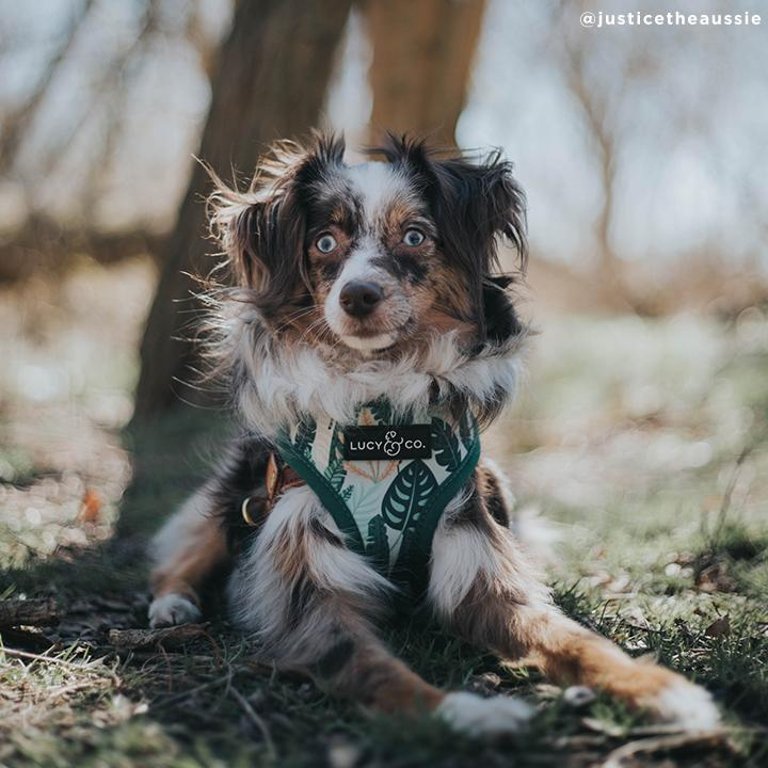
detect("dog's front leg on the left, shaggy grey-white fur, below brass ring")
[230,487,529,731]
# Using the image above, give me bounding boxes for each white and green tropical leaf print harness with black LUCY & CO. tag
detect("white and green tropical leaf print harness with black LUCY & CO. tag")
[277,401,480,591]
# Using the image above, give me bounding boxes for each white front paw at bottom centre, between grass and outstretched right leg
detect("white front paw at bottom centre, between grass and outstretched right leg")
[435,691,536,736]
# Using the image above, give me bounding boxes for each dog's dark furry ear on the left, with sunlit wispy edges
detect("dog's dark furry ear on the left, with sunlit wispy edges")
[208,134,344,317]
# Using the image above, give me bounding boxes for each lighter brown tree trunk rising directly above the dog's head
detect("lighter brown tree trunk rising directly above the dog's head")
[366,0,485,147]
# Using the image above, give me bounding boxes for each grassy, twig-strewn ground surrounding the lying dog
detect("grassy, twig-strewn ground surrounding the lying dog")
[0,262,768,768]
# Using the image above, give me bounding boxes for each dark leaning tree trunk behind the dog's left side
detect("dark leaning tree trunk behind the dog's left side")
[134,0,351,422]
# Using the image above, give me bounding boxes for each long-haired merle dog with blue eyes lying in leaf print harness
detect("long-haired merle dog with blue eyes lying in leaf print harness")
[149,134,719,736]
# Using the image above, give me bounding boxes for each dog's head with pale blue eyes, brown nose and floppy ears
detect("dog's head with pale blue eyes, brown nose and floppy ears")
[212,131,525,358]
